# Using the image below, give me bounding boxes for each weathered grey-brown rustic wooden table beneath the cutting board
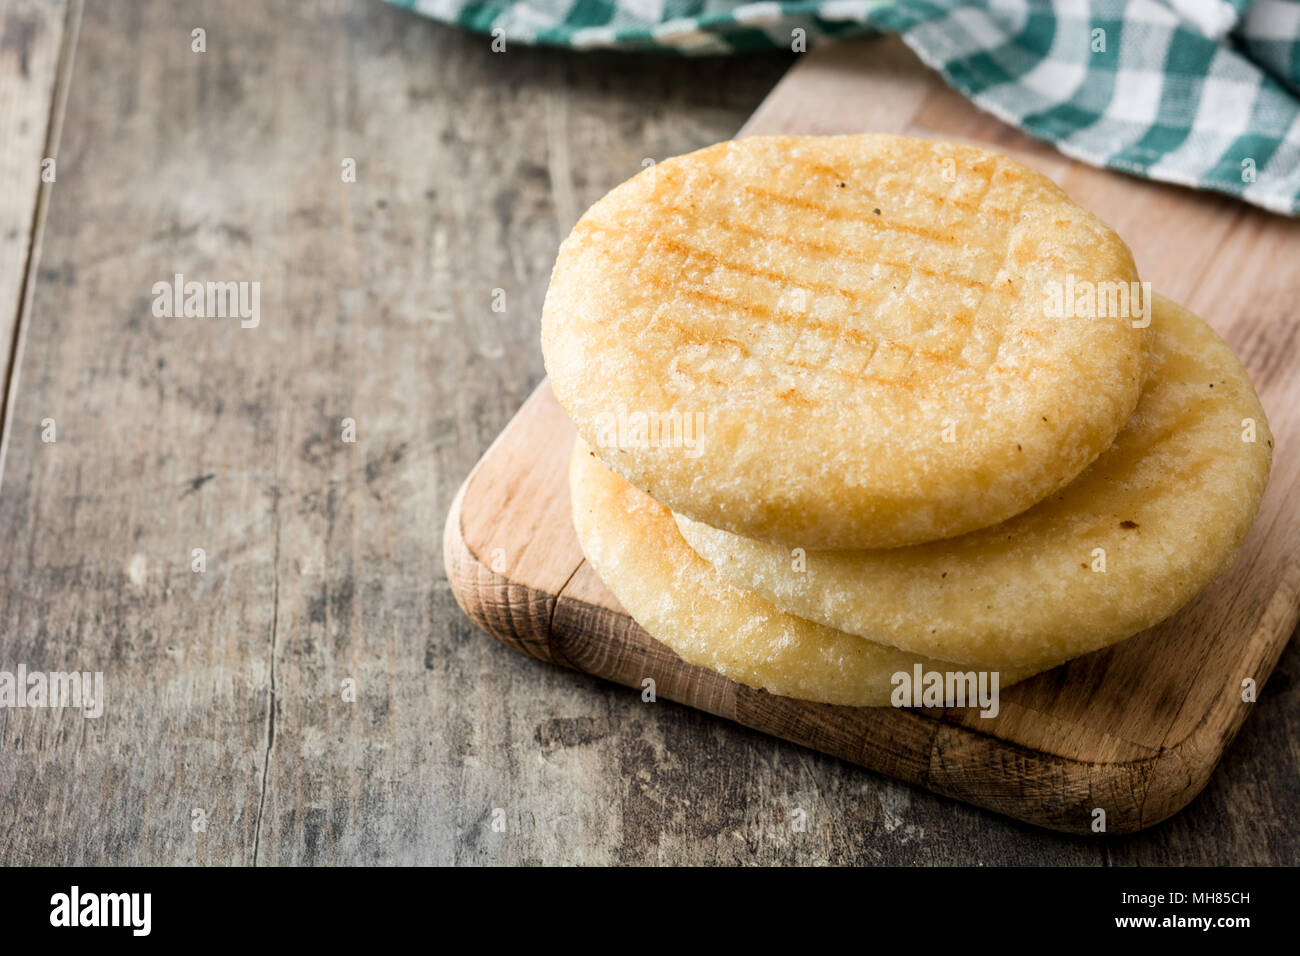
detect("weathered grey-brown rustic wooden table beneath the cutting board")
[0,0,1300,865]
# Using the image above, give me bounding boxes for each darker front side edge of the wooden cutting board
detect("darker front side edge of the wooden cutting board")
[443,378,1300,834]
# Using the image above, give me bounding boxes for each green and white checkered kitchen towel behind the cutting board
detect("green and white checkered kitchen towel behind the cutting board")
[389,0,1300,216]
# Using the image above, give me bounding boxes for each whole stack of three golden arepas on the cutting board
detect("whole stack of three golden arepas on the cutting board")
[542,135,1273,706]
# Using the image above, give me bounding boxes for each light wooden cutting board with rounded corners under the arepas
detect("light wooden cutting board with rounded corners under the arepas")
[443,39,1300,832]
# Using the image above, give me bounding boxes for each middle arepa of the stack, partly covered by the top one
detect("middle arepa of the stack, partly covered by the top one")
[679,295,1273,671]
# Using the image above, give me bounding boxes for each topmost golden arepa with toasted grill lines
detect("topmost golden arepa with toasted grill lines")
[542,135,1148,549]
